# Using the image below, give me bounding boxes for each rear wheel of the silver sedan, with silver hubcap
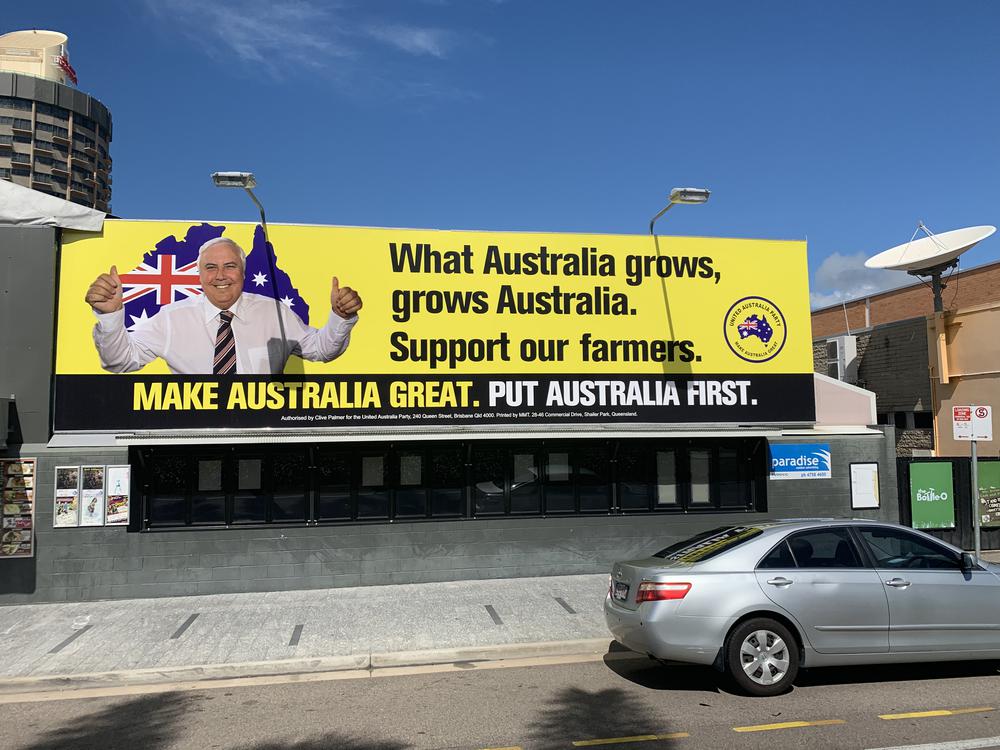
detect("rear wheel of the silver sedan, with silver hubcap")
[725,617,799,697]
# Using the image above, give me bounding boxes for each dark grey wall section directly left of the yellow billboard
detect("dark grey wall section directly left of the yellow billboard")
[0,227,56,443]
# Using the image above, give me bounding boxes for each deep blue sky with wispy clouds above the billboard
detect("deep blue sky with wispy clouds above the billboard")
[0,0,1000,305]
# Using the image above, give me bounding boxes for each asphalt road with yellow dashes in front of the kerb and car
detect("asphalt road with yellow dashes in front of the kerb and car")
[0,654,1000,750]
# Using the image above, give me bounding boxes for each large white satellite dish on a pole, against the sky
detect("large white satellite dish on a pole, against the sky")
[865,222,997,312]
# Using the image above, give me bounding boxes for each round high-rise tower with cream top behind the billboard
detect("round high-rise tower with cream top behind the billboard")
[0,30,111,211]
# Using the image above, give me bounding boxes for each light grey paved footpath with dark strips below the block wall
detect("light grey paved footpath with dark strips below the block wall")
[0,575,611,694]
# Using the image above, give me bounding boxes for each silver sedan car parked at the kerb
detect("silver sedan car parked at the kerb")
[604,519,1000,696]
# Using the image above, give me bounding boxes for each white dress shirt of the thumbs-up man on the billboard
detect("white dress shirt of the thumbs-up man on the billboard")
[94,293,358,375]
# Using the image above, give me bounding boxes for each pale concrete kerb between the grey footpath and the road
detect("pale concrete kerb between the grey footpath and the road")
[0,638,612,695]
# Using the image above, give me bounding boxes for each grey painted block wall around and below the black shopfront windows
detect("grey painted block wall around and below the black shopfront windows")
[0,428,897,604]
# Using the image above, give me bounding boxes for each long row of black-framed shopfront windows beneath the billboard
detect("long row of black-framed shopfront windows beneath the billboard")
[132,439,767,528]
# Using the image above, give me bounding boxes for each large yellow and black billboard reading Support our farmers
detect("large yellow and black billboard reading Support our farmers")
[55,220,815,431]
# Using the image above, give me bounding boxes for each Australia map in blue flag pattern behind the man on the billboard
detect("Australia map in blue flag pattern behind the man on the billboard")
[119,224,309,330]
